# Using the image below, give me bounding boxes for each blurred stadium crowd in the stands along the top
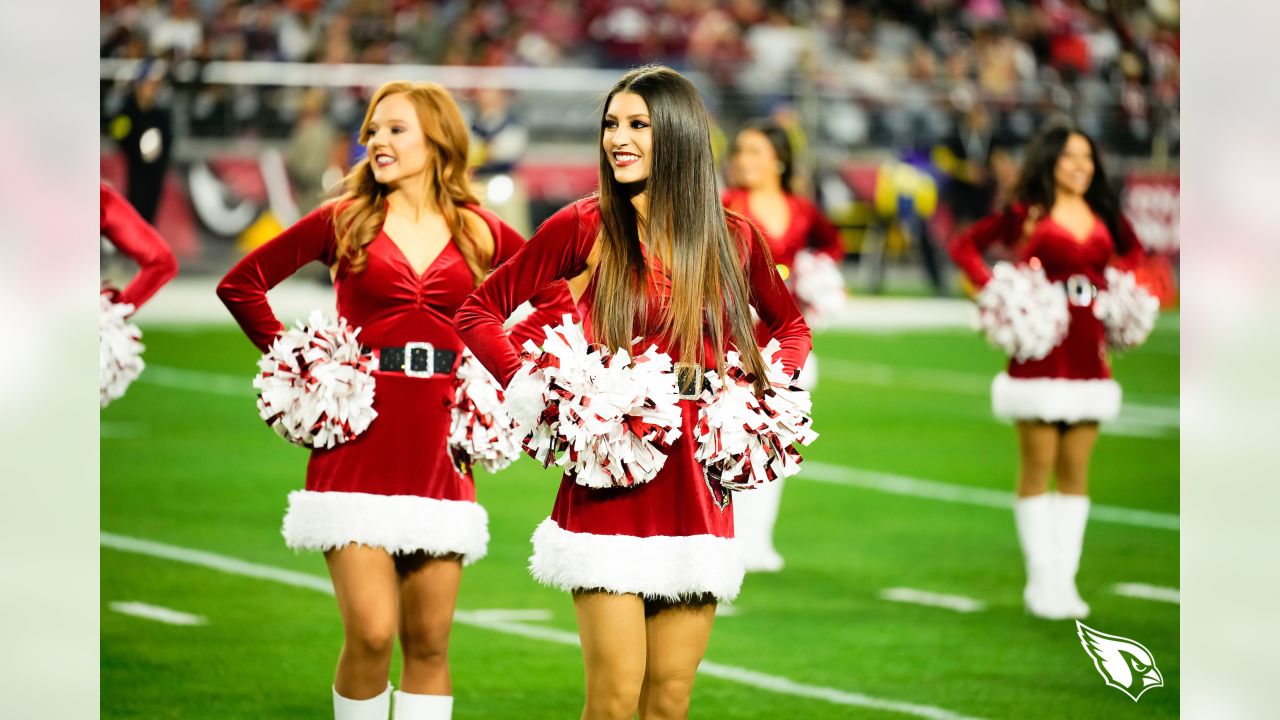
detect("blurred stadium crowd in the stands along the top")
[101,0,1179,154]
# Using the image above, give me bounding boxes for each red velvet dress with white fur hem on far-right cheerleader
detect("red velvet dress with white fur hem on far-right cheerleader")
[951,205,1143,423]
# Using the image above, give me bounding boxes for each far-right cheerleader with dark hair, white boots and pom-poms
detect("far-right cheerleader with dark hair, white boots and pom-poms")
[951,124,1156,619]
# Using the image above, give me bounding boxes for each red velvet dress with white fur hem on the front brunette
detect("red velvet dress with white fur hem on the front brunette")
[457,197,810,601]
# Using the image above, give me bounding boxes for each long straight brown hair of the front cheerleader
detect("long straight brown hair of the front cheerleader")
[591,65,768,392]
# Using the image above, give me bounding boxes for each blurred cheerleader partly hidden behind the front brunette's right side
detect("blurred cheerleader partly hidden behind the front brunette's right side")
[722,120,845,573]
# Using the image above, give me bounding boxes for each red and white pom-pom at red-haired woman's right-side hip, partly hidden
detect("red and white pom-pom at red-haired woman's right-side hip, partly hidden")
[449,350,521,473]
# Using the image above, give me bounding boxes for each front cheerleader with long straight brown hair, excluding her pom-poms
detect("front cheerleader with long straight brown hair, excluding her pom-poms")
[457,67,810,719]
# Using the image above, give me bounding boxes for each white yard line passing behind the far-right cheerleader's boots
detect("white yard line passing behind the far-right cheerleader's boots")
[797,460,1179,530]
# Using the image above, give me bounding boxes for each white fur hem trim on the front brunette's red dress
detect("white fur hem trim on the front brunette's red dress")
[529,518,742,602]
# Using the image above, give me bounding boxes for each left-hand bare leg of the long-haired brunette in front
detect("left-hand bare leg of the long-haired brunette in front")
[573,592,645,720]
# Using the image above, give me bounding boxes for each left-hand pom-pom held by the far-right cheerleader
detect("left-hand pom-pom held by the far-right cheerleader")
[977,263,1071,363]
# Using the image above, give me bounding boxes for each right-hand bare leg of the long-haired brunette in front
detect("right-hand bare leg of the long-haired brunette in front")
[640,602,716,720]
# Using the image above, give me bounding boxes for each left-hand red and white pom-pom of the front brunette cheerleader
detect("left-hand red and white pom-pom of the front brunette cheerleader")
[507,318,681,488]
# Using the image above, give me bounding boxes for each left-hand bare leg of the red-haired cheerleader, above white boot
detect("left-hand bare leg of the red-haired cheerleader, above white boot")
[325,543,398,700]
